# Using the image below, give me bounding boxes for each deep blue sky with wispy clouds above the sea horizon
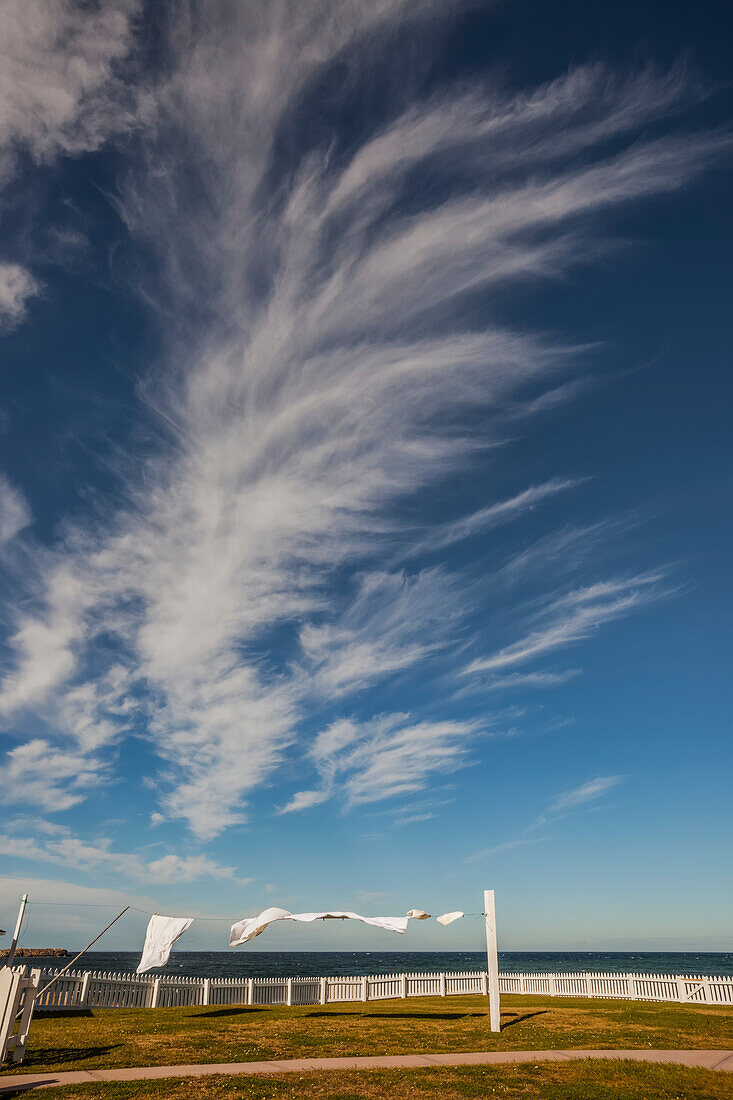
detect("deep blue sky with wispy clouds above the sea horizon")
[0,0,733,950]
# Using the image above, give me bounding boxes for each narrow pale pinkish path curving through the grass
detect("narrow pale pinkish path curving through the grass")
[0,1051,733,1093]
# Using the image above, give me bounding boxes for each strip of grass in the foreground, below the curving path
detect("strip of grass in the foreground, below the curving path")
[2,1059,733,1100]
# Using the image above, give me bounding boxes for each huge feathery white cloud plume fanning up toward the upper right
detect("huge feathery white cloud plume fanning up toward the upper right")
[0,0,730,838]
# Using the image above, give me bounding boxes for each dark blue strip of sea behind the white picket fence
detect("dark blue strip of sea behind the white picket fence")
[62,948,733,978]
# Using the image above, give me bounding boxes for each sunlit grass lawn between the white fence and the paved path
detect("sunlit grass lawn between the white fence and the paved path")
[2,996,733,1078]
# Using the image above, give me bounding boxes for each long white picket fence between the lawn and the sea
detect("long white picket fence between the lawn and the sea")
[11,967,733,1010]
